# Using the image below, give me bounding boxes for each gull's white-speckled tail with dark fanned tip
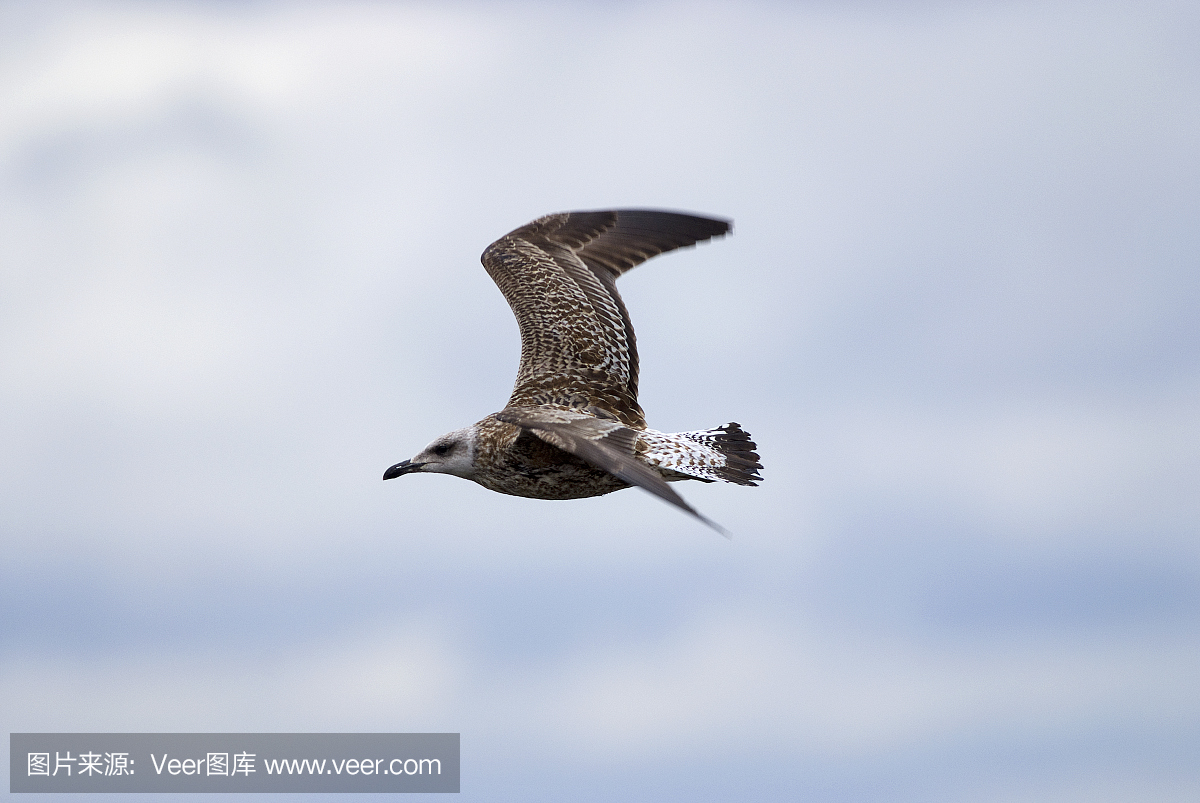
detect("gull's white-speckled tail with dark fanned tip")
[638,423,762,485]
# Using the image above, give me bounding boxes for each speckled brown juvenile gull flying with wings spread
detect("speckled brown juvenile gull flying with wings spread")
[383,209,762,533]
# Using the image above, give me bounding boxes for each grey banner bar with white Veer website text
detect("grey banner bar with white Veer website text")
[8,733,458,792]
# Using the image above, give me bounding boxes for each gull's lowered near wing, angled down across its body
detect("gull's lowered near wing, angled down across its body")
[494,407,728,538]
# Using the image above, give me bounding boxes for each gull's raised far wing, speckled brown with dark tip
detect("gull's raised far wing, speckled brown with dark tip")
[482,209,730,427]
